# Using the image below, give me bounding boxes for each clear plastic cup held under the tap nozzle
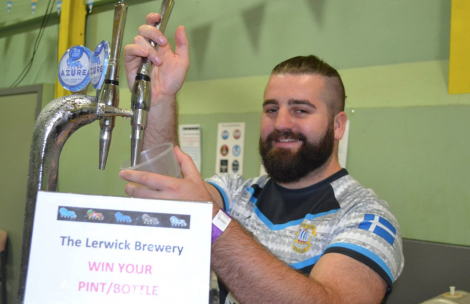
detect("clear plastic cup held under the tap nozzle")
[121,143,181,178]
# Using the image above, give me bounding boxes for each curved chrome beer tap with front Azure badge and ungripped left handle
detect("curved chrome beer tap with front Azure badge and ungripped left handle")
[16,2,133,303]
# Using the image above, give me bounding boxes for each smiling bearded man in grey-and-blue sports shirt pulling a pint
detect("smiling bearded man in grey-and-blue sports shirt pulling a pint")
[120,14,404,304]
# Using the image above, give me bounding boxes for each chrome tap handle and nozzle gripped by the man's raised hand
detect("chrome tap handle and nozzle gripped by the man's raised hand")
[131,0,175,166]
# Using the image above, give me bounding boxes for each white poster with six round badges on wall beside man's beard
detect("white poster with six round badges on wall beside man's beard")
[215,122,245,175]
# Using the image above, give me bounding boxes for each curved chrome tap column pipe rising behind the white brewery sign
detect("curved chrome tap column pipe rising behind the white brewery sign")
[17,95,132,303]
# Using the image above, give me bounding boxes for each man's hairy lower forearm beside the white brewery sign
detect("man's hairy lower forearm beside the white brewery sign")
[211,221,340,303]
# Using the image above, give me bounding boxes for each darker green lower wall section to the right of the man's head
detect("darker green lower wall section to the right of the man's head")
[347,105,470,246]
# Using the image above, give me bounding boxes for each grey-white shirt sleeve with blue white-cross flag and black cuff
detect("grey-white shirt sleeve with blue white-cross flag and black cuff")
[324,197,404,289]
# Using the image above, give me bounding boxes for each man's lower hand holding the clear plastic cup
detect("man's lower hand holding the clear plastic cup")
[119,146,218,211]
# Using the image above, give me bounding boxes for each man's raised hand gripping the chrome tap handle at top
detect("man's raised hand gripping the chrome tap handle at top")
[124,13,189,106]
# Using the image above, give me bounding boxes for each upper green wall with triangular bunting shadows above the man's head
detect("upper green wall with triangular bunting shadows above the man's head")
[86,0,451,81]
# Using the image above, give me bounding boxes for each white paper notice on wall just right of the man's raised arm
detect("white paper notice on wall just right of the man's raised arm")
[179,125,201,173]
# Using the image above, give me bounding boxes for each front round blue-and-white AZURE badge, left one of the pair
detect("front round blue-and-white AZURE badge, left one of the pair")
[57,45,92,92]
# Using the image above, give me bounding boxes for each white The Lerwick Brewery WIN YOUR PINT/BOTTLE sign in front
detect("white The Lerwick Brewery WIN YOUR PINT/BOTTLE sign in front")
[24,192,212,304]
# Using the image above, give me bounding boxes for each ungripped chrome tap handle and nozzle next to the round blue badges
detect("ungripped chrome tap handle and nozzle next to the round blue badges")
[99,2,127,170]
